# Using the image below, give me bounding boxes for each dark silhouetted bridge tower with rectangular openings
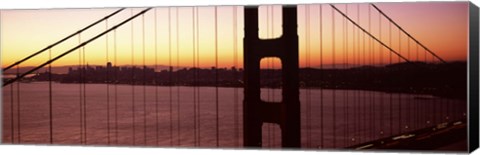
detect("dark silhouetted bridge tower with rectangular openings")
[243,6,300,148]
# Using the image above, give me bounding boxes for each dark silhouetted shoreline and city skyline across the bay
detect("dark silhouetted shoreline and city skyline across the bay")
[14,62,467,99]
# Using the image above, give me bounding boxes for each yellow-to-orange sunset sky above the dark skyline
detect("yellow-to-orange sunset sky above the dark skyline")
[0,2,468,68]
